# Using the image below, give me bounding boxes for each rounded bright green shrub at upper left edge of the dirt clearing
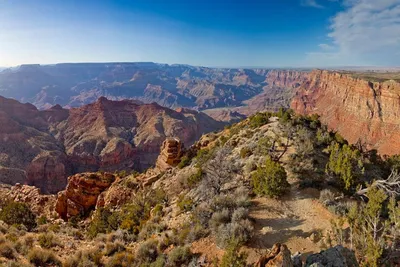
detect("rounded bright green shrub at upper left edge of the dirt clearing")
[252,157,289,197]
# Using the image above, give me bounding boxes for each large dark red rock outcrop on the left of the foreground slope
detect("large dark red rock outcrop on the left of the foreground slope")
[55,173,116,220]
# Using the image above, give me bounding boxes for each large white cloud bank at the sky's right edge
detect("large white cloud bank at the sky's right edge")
[308,0,400,65]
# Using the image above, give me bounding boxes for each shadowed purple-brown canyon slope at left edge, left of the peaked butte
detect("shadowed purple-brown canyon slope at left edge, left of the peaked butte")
[0,97,69,193]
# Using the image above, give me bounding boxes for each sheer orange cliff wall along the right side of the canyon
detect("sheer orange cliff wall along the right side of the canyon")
[291,70,400,155]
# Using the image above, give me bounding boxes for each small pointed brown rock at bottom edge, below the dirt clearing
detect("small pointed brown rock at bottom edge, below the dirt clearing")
[255,244,293,267]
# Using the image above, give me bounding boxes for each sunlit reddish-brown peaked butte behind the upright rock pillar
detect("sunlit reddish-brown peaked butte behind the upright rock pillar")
[52,97,223,172]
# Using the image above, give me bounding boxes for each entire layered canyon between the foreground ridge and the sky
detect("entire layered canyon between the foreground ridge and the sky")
[0,63,400,193]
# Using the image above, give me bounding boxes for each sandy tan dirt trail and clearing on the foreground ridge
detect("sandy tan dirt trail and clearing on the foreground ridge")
[246,136,334,262]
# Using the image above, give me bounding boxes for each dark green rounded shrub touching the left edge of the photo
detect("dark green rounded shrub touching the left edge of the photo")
[0,201,37,231]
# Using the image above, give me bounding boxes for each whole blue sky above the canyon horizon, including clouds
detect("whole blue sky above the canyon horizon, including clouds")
[0,0,400,67]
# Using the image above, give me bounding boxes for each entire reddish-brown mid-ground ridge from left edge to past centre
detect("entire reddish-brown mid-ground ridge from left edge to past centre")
[0,97,225,193]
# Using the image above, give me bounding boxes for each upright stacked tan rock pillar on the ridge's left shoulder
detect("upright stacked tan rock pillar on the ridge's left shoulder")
[156,138,183,170]
